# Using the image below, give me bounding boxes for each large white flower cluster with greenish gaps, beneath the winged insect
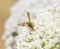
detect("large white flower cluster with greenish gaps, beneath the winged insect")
[3,0,60,49]
